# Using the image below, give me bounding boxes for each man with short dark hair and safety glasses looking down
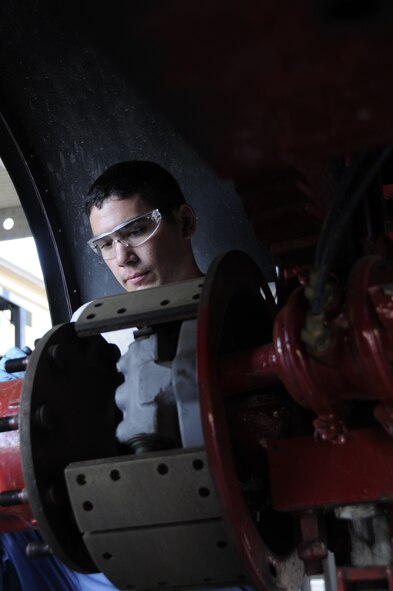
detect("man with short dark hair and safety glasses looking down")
[73,160,202,589]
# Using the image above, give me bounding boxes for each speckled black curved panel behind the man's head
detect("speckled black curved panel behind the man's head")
[0,0,270,323]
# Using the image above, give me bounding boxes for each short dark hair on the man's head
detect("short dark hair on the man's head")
[85,160,185,216]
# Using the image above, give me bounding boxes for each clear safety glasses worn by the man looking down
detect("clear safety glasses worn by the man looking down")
[88,209,161,259]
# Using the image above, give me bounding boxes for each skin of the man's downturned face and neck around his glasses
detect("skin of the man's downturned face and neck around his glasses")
[90,196,198,291]
